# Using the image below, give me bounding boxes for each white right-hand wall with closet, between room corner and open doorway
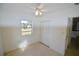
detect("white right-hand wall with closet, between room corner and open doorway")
[41,17,67,55]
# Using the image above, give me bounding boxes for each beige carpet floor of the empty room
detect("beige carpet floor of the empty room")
[6,43,61,56]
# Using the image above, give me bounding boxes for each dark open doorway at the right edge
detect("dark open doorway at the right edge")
[65,17,79,56]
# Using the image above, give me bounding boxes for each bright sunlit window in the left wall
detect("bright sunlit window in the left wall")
[21,20,32,36]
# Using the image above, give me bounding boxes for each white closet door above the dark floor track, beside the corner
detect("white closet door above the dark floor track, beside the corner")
[41,22,49,47]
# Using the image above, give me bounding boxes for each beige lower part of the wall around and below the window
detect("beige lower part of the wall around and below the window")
[1,27,40,52]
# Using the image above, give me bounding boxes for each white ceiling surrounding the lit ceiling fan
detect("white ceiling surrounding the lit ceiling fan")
[0,3,79,25]
